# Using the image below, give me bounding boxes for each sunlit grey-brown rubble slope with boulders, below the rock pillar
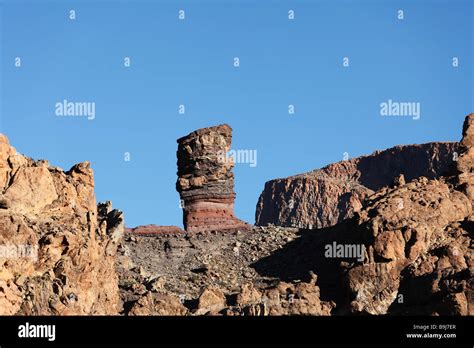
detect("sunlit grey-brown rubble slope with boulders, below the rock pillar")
[117,227,335,316]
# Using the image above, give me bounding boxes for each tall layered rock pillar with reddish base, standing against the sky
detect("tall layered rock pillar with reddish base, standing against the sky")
[176,124,247,232]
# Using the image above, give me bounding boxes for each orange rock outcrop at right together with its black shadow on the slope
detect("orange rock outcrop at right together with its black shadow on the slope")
[250,114,474,315]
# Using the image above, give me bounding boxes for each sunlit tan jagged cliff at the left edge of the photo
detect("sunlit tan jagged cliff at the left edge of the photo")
[0,134,123,315]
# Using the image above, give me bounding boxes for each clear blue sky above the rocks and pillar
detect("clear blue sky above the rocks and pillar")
[0,0,474,226]
